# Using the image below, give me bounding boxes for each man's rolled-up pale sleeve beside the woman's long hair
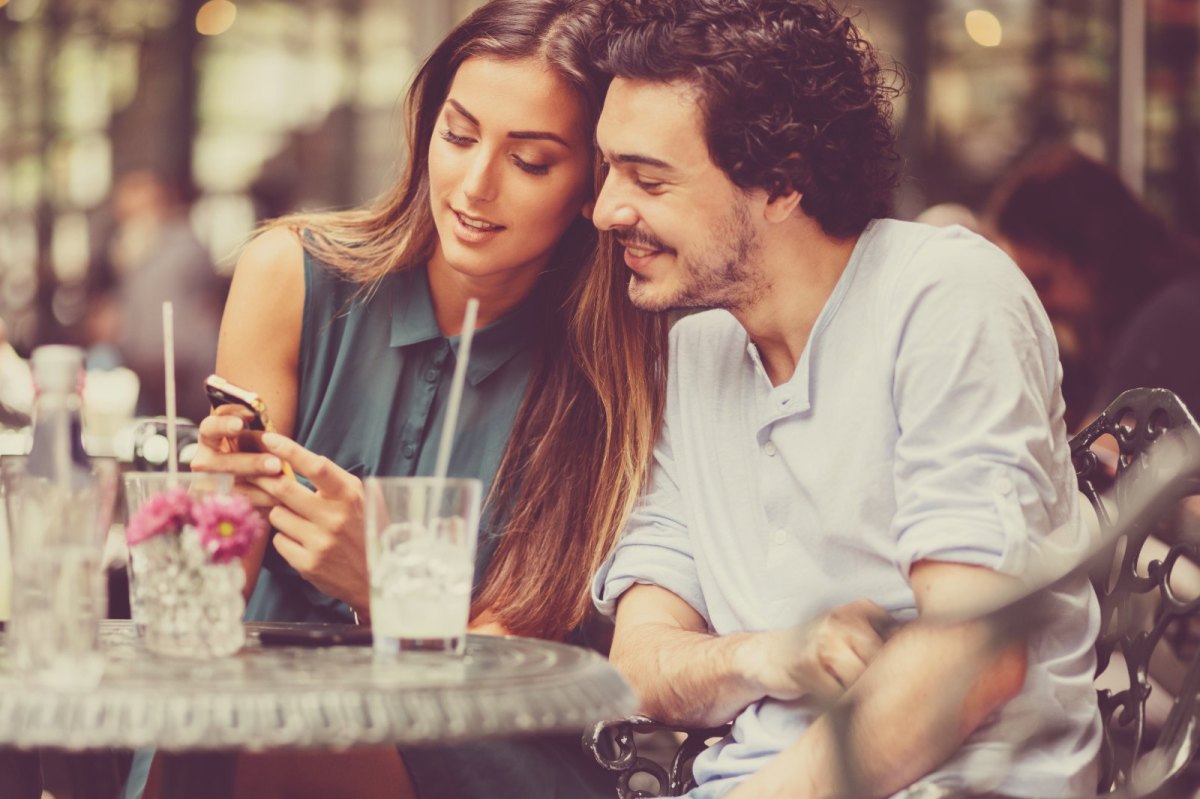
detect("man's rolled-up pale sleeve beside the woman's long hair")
[592,422,708,620]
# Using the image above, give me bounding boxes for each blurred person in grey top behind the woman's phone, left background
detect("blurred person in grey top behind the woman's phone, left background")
[98,169,226,421]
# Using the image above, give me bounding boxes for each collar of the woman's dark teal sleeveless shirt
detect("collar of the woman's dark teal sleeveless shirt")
[389,266,535,385]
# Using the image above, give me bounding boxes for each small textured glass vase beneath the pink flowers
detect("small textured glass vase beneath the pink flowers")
[130,524,246,657]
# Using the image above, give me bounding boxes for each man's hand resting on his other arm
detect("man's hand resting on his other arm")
[739,600,893,703]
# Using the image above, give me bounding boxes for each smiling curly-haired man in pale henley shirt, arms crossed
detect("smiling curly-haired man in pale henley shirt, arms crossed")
[585,0,1099,799]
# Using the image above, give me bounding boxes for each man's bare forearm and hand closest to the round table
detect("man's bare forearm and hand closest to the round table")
[610,584,890,727]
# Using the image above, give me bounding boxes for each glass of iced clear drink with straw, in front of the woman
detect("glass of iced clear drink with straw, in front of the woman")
[364,477,482,655]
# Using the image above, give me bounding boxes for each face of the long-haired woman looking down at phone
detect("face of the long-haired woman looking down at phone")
[428,58,593,286]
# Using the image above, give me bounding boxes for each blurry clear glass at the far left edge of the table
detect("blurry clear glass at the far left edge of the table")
[0,456,119,689]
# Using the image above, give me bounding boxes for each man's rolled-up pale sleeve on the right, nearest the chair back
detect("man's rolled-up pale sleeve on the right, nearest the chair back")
[893,247,1072,575]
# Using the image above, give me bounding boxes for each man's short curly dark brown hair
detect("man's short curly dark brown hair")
[596,0,898,236]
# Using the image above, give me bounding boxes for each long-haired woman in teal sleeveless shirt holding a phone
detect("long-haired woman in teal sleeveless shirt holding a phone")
[139,0,665,798]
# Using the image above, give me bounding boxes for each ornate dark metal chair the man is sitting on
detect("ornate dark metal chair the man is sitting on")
[583,389,1200,799]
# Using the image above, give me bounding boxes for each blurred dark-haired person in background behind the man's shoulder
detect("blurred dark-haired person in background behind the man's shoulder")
[985,146,1200,431]
